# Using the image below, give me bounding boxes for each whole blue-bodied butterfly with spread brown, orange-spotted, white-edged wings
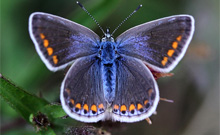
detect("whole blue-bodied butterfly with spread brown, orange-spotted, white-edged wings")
[29,7,194,123]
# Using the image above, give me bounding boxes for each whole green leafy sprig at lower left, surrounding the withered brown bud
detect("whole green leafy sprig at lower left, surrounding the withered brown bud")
[0,74,74,135]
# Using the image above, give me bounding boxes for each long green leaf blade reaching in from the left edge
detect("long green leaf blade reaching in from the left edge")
[0,74,48,121]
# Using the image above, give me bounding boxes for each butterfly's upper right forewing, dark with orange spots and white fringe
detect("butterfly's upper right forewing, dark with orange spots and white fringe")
[116,15,194,72]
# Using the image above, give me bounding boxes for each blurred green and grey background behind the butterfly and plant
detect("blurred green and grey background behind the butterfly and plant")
[0,0,219,135]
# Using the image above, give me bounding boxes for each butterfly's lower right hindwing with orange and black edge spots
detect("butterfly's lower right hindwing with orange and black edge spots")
[112,56,159,122]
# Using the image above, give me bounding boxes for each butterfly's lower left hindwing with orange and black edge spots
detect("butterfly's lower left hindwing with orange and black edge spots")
[60,55,107,122]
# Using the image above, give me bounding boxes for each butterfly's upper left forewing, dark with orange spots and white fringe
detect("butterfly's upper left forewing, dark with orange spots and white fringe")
[29,12,100,71]
